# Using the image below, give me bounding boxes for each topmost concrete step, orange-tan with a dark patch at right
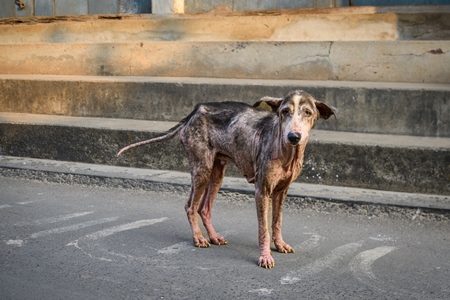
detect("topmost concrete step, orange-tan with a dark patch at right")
[0,5,450,44]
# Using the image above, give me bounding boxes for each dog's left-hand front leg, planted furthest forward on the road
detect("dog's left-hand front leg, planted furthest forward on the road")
[255,188,275,269]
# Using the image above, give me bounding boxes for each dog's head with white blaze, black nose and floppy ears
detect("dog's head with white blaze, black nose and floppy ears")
[253,90,338,146]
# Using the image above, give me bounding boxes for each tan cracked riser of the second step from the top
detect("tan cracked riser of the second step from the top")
[0,41,450,83]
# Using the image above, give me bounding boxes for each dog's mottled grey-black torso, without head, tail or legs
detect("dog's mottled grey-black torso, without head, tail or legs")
[180,102,277,179]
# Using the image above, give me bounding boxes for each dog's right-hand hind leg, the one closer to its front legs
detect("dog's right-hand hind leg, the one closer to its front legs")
[198,158,228,245]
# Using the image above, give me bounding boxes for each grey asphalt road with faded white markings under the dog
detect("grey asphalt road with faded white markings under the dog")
[0,178,450,299]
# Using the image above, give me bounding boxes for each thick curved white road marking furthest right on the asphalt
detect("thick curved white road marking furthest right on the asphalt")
[349,246,397,286]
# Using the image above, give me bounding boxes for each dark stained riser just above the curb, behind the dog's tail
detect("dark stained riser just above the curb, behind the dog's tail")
[0,123,450,195]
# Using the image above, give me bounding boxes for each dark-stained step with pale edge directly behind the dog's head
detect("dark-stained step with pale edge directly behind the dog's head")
[0,75,450,137]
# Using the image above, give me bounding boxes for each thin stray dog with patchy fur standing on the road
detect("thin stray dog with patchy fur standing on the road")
[118,90,337,269]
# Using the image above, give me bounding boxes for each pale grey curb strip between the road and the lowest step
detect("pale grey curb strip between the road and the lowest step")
[0,156,450,210]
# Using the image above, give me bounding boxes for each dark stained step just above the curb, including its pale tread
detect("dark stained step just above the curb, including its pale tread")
[0,113,450,195]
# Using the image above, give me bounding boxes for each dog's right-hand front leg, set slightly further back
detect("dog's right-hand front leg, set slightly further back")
[272,190,294,253]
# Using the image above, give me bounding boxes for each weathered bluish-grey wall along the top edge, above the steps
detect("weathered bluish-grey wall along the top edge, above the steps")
[0,0,450,18]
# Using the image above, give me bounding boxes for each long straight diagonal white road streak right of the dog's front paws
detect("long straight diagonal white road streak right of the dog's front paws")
[280,242,362,284]
